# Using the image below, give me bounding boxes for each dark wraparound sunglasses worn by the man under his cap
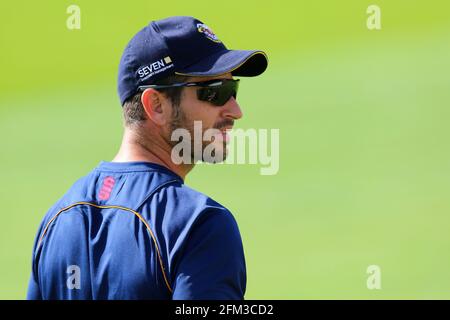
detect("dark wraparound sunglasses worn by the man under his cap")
[139,79,239,106]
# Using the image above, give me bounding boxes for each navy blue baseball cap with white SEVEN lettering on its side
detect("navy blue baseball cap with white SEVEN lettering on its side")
[118,17,268,105]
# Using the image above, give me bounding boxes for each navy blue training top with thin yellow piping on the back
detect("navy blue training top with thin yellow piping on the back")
[27,162,246,299]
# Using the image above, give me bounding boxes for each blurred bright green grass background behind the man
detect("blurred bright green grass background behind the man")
[0,0,450,299]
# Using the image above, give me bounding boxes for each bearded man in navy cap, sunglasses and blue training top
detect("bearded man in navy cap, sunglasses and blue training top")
[28,17,267,299]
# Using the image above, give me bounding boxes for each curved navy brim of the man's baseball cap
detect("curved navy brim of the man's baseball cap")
[176,50,268,77]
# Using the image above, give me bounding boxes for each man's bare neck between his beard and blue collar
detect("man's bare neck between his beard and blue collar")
[112,129,194,180]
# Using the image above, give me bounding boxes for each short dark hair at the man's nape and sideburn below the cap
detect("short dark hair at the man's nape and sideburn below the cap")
[122,75,188,126]
